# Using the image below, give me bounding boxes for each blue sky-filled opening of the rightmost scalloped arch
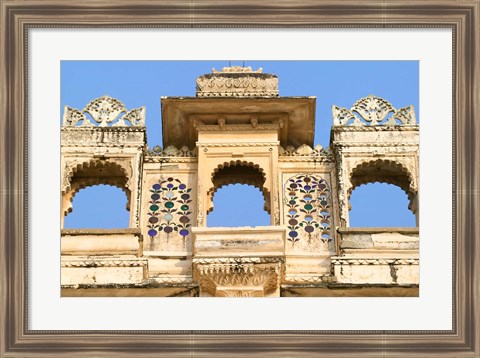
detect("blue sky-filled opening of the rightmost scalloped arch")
[349,183,415,227]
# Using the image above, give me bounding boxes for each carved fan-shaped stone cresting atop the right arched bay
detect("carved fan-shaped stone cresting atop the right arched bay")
[332,95,416,126]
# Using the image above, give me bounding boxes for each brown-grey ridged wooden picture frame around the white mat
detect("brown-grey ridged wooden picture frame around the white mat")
[0,0,480,357]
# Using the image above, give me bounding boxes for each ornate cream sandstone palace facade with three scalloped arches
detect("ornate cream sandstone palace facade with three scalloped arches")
[61,67,419,297]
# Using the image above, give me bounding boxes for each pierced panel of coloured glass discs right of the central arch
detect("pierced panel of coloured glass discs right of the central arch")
[284,174,333,245]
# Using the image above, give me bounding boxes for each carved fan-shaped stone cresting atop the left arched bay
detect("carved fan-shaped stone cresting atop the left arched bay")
[62,96,145,127]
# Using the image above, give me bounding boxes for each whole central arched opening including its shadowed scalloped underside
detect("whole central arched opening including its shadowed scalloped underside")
[207,161,271,227]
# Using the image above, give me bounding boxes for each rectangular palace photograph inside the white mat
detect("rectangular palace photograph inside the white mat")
[60,60,420,298]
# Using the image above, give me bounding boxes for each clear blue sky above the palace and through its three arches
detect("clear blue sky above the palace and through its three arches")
[59,60,421,228]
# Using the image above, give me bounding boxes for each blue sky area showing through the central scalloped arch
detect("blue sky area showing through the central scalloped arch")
[207,184,270,227]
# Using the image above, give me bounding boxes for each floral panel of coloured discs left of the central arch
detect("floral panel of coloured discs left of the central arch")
[147,178,192,240]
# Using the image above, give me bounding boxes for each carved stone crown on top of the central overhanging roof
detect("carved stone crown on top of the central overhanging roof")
[196,66,278,97]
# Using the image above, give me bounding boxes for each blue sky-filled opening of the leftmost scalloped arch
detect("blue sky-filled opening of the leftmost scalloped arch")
[64,184,130,229]
